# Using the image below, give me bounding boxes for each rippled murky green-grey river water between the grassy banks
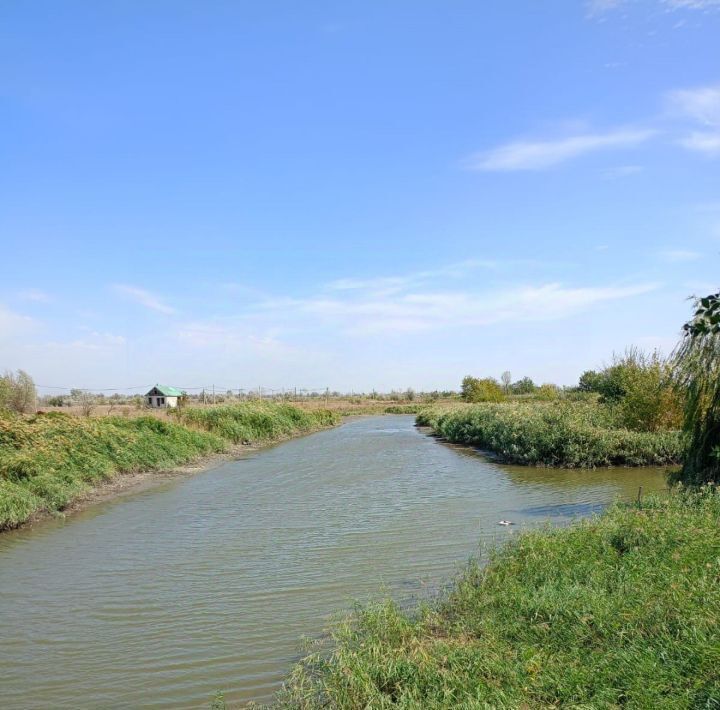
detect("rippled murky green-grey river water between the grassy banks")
[0,416,664,708]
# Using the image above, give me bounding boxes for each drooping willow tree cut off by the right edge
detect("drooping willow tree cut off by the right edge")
[674,292,720,485]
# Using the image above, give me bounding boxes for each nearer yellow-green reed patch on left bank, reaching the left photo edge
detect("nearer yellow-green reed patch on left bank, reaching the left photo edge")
[0,412,226,530]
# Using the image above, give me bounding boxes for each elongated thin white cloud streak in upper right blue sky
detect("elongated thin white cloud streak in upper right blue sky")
[465,129,657,172]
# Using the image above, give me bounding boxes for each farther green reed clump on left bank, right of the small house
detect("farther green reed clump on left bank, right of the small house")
[176,402,340,444]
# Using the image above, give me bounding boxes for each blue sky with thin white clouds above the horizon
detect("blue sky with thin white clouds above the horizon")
[0,0,720,391]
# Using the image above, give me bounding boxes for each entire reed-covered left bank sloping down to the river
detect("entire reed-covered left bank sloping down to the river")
[0,403,339,531]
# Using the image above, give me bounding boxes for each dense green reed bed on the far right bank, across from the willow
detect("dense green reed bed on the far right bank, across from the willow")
[417,402,683,468]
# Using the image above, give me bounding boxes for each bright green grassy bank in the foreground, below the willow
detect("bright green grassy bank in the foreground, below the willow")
[281,489,720,710]
